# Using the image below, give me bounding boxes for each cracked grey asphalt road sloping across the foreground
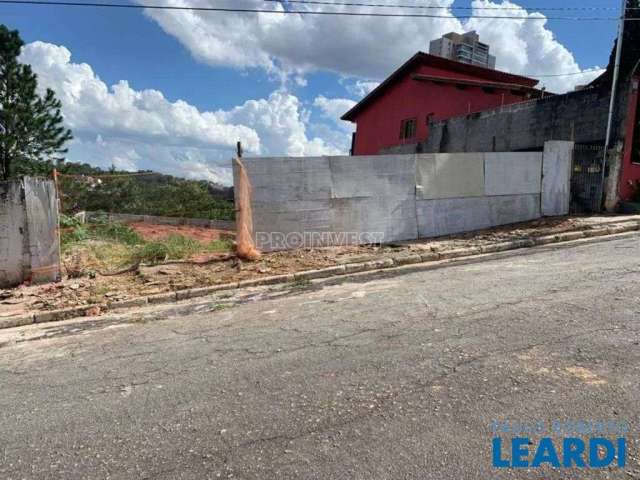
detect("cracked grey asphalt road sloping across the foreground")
[0,237,640,480]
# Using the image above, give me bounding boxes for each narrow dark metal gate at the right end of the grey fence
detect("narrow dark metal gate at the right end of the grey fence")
[570,144,604,213]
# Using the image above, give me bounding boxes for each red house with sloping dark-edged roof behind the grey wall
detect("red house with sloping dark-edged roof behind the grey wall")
[342,52,543,155]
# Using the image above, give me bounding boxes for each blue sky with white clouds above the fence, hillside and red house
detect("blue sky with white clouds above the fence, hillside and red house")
[0,0,617,181]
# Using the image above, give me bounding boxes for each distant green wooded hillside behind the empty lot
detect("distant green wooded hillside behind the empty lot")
[58,162,234,220]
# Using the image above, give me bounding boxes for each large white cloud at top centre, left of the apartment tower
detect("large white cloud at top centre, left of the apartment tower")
[141,0,461,78]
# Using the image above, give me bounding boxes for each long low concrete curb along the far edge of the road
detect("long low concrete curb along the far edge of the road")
[0,222,640,330]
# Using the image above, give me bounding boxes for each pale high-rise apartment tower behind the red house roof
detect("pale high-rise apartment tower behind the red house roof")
[429,30,496,69]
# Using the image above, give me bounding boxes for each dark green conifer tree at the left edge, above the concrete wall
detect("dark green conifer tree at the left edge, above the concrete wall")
[0,25,72,180]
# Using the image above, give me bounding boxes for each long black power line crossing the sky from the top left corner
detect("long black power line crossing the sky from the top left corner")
[0,0,624,21]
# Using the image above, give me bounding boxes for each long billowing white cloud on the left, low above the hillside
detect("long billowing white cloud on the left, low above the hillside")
[21,42,260,151]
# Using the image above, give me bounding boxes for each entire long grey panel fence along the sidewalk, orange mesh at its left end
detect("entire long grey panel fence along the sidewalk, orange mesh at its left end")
[234,142,572,251]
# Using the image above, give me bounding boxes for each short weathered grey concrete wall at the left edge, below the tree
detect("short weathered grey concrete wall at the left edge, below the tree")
[0,177,60,288]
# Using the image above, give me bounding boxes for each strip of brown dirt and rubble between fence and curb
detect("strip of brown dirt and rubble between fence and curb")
[0,216,640,318]
